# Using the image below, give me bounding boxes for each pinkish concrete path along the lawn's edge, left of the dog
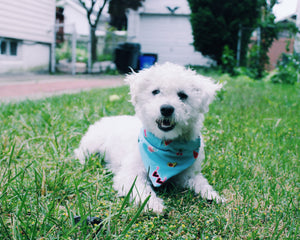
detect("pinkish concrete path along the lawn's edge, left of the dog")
[0,73,124,102]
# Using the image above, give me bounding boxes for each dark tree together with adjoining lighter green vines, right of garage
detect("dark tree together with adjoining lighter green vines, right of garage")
[189,0,297,79]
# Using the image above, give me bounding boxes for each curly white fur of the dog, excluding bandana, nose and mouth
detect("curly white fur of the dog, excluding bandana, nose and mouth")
[75,63,224,213]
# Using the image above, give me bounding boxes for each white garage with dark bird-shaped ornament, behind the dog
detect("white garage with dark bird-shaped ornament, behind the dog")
[127,0,213,65]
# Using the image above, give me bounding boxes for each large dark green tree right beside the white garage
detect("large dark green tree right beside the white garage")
[188,0,264,65]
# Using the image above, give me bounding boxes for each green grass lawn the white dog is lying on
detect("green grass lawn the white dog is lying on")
[0,75,300,239]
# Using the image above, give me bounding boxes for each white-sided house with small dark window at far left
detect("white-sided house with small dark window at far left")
[0,0,55,73]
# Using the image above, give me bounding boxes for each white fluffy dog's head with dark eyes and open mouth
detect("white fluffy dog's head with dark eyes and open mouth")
[126,63,221,140]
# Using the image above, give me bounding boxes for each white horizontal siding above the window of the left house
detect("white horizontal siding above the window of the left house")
[0,0,55,43]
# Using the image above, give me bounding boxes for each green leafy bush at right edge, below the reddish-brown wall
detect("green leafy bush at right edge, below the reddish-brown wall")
[271,54,300,84]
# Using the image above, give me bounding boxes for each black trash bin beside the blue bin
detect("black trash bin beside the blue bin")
[115,42,141,73]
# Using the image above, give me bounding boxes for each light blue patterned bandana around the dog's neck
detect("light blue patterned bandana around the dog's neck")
[139,128,201,187]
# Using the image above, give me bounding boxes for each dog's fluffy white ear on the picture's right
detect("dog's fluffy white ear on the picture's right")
[195,76,223,113]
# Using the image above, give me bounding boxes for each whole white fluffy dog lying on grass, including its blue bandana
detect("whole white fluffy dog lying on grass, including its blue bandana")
[75,63,224,213]
